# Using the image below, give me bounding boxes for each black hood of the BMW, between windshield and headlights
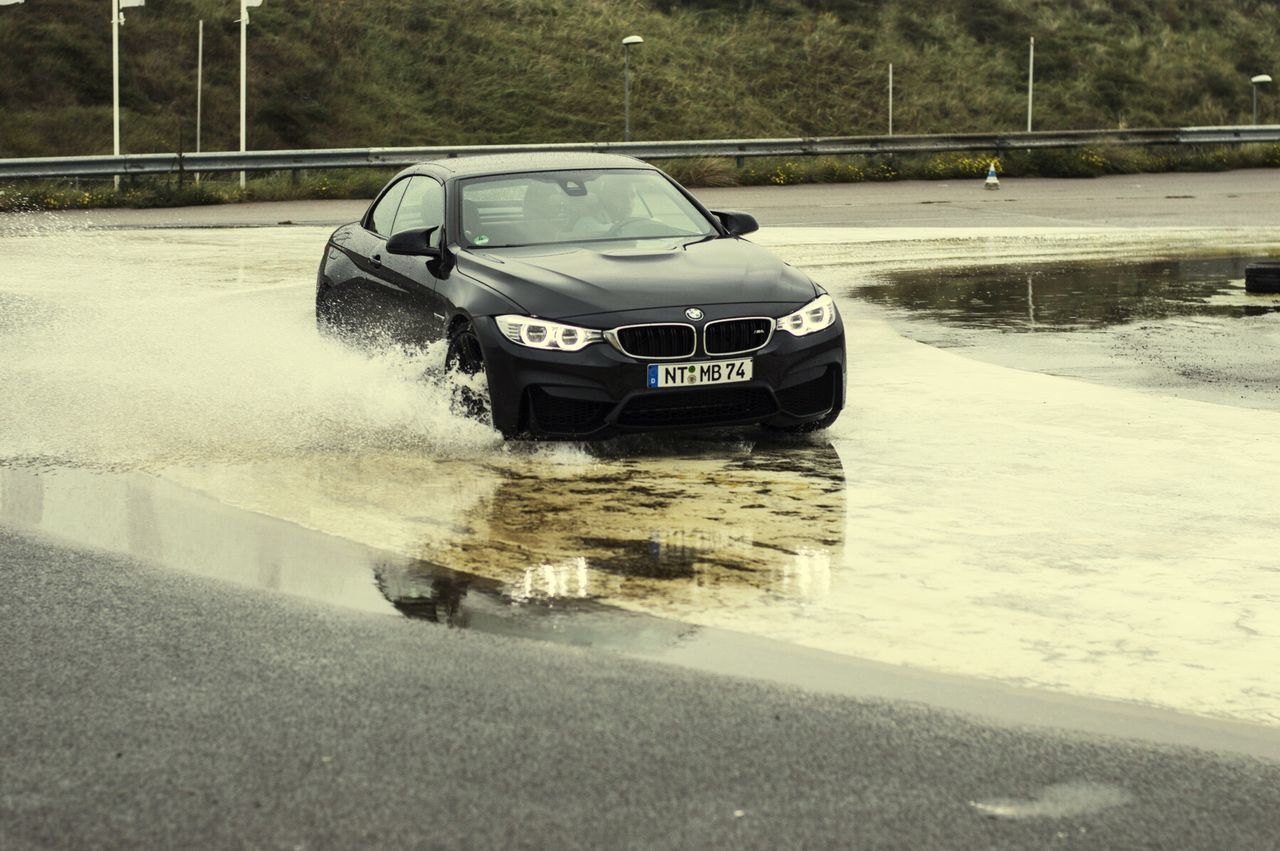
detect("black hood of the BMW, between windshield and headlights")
[457,238,818,319]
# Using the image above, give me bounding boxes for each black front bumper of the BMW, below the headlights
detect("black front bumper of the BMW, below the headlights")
[474,310,845,439]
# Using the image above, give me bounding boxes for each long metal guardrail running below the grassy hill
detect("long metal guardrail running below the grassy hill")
[0,124,1280,179]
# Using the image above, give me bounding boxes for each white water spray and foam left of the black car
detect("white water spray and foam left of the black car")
[0,215,500,467]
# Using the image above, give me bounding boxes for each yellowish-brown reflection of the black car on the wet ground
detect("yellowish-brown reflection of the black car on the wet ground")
[378,441,845,626]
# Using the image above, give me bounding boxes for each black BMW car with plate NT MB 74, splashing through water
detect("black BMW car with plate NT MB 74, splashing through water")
[316,154,845,438]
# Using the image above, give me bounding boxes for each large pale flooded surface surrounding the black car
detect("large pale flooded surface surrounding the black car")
[0,222,1280,728]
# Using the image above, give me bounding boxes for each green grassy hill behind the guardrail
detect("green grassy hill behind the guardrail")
[0,0,1280,157]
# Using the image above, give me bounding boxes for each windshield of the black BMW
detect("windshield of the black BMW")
[462,169,718,248]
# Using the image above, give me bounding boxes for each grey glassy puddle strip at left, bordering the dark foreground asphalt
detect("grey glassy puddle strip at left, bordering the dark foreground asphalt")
[0,466,689,651]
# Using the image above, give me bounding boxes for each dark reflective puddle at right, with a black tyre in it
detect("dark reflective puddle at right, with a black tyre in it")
[854,255,1280,410]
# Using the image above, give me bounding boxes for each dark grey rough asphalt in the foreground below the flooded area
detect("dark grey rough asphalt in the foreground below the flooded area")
[0,524,1280,850]
